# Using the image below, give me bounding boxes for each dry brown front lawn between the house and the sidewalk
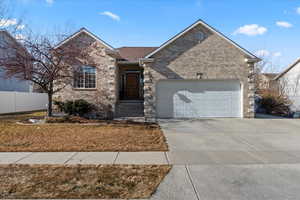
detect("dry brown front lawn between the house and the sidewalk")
[0,113,168,152]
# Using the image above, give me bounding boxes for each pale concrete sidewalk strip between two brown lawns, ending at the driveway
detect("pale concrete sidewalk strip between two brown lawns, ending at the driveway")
[0,152,169,165]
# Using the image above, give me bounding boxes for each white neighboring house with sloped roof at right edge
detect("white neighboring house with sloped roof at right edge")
[275,59,300,112]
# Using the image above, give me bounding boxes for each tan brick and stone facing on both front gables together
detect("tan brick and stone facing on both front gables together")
[54,24,254,120]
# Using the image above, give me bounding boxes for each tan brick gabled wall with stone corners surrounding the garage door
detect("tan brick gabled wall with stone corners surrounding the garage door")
[141,25,254,119]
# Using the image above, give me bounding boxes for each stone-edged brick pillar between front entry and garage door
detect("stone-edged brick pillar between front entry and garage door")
[140,59,156,121]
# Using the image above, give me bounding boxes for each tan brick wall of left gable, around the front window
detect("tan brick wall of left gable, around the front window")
[54,33,118,118]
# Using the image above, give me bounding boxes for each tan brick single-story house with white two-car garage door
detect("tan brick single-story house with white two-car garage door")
[55,20,259,119]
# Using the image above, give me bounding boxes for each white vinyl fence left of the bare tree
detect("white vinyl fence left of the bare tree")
[0,92,48,114]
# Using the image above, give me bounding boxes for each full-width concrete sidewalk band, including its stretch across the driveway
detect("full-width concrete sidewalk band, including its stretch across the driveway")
[4,151,300,165]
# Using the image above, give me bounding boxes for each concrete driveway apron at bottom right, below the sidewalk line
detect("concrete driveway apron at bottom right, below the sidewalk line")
[150,164,300,200]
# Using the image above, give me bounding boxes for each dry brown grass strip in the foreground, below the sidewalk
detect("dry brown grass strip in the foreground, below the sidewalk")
[0,165,171,199]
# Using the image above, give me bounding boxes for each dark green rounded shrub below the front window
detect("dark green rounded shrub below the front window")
[58,99,93,117]
